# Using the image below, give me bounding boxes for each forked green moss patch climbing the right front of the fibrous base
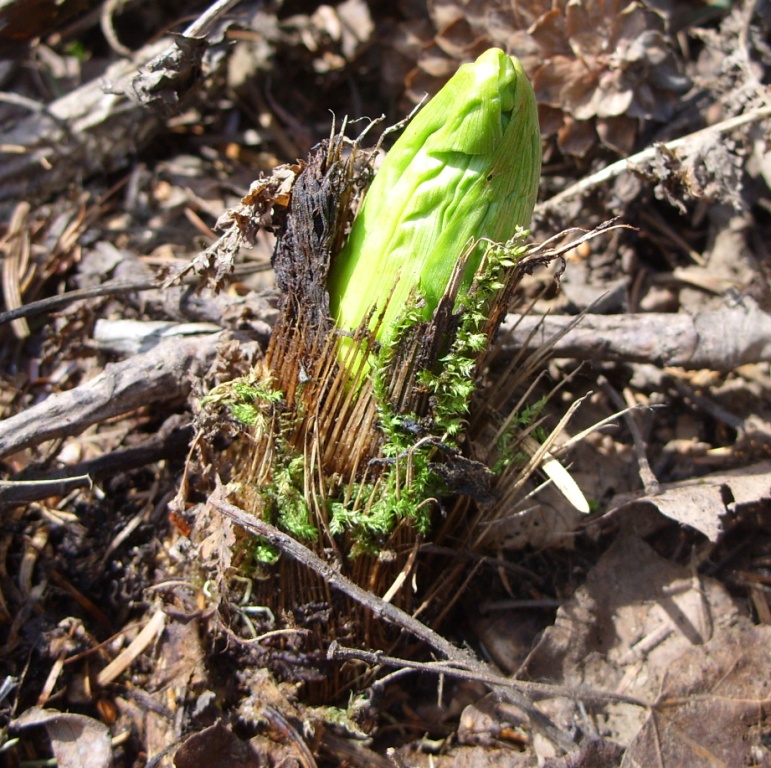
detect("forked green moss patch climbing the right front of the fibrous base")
[320,229,542,551]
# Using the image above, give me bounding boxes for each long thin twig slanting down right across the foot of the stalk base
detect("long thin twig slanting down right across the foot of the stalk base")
[209,485,576,752]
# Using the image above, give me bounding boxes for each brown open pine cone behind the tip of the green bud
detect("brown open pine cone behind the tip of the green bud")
[398,0,690,157]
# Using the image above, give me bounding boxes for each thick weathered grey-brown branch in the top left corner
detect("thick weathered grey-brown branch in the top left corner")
[0,0,234,208]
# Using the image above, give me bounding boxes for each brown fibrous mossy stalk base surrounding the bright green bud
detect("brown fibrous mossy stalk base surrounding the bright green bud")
[188,137,608,701]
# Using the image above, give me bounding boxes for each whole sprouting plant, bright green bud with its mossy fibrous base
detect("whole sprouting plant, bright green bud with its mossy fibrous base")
[213,49,541,560]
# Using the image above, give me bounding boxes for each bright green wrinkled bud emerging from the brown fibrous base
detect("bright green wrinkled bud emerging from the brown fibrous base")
[327,48,541,343]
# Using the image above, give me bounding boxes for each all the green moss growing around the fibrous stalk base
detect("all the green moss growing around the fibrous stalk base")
[220,229,543,552]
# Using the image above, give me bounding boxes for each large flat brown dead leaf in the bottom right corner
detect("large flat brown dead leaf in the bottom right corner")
[524,526,771,768]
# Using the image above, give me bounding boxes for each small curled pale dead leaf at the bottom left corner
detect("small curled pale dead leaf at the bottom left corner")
[11,707,112,768]
